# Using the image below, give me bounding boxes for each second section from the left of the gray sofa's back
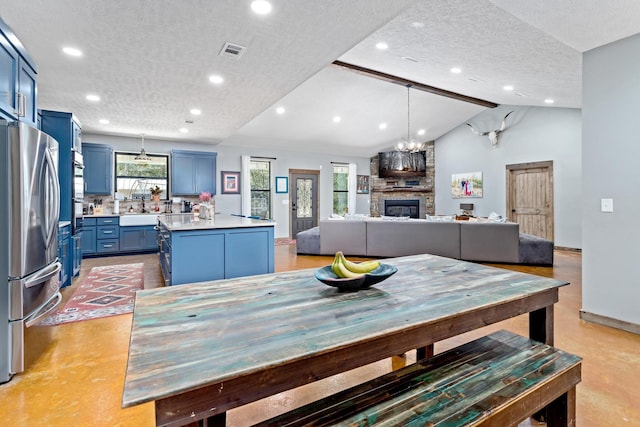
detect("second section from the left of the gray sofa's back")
[320,220,367,256]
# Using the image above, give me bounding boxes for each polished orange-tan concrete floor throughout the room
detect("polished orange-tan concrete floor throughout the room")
[0,246,640,427]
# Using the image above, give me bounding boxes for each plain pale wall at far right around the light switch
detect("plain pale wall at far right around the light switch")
[582,35,640,325]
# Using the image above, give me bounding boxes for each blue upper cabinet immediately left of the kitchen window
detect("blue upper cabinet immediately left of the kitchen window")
[82,143,113,195]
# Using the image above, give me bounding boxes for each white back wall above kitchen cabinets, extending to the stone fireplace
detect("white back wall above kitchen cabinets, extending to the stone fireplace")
[82,133,369,237]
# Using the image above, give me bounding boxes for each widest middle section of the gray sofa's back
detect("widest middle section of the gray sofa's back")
[367,220,460,258]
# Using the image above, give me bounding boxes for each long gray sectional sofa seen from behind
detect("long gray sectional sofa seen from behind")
[296,218,553,265]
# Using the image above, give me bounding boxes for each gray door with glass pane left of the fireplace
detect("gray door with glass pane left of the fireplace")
[289,170,320,239]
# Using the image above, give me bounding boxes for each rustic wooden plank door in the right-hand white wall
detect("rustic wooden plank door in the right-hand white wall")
[506,161,553,240]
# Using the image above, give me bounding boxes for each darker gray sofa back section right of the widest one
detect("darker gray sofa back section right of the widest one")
[460,221,520,263]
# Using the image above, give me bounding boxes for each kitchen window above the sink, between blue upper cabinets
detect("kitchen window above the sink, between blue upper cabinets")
[114,152,169,200]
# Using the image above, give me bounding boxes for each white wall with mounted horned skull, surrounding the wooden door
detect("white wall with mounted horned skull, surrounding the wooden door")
[435,105,582,248]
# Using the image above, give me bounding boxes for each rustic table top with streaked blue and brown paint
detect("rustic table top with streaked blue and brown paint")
[122,255,567,407]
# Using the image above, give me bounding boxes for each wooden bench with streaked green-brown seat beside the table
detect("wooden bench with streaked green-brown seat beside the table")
[257,331,581,427]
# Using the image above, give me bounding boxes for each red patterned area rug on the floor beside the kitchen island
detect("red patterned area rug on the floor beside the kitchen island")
[40,263,144,325]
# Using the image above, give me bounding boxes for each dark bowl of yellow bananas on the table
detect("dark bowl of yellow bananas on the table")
[315,251,398,291]
